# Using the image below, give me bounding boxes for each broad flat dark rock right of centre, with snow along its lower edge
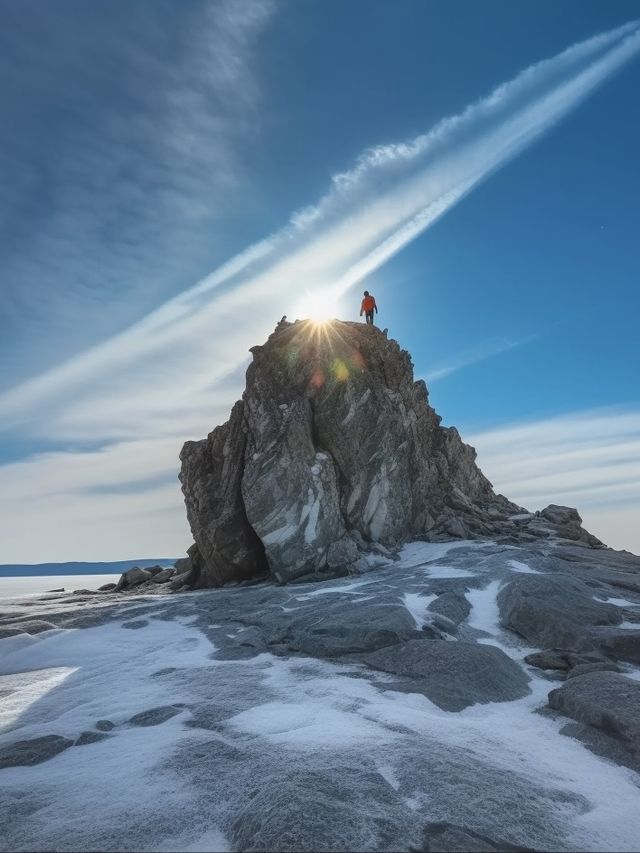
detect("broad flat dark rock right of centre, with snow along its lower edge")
[359,640,529,711]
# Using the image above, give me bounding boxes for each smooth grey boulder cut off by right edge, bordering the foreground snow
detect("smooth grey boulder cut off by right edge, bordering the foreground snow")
[549,672,640,758]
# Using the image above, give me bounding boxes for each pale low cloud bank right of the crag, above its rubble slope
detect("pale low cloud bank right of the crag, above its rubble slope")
[465,408,640,553]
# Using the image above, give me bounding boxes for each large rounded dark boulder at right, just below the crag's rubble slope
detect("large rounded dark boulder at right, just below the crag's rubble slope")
[498,574,622,651]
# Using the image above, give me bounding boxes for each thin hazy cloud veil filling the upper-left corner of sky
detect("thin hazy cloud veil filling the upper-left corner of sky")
[0,0,276,388]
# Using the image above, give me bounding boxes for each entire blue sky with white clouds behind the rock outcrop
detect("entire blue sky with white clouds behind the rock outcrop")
[0,0,640,562]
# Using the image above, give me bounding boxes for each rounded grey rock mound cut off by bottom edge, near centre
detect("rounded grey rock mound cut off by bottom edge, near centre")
[231,764,420,853]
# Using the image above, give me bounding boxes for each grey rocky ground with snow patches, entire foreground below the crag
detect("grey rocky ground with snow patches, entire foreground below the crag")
[0,540,640,853]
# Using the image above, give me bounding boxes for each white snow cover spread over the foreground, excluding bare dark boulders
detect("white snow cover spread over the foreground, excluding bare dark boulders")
[0,543,640,851]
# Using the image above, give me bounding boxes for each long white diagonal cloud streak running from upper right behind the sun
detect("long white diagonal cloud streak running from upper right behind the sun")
[0,22,640,440]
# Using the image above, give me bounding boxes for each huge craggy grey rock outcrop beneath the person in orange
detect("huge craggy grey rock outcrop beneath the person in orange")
[180,320,601,587]
